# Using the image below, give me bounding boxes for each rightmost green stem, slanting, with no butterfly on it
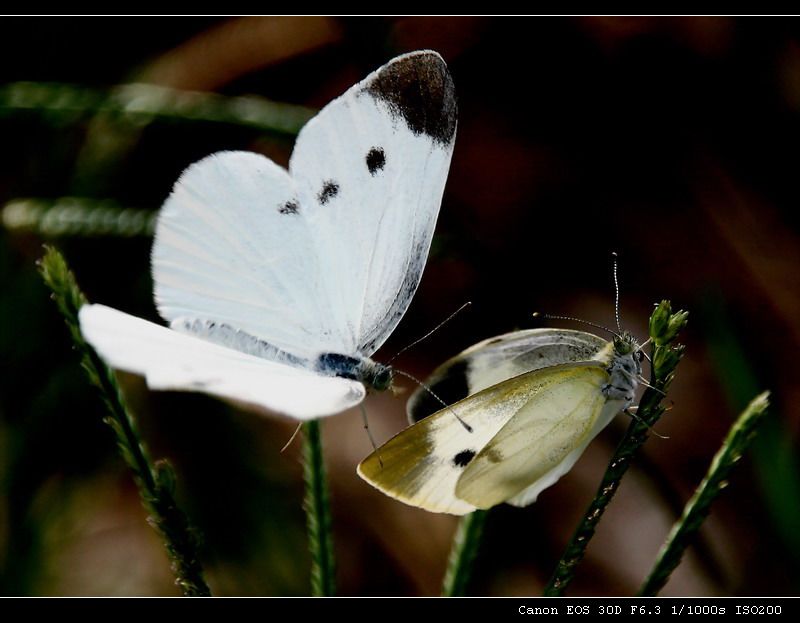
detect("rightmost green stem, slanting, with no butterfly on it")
[638,392,769,597]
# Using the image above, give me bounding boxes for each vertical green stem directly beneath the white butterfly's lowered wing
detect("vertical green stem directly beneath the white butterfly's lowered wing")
[303,420,336,597]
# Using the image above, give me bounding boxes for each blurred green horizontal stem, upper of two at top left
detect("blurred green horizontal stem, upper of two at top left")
[0,82,314,136]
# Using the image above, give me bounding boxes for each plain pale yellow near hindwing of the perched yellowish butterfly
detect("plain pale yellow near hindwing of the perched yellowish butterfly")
[455,363,612,508]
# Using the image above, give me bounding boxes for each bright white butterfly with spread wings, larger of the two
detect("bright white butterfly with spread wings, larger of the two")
[80,51,456,419]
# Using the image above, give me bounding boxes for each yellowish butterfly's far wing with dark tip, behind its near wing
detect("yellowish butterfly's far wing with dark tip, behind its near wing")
[406,329,610,423]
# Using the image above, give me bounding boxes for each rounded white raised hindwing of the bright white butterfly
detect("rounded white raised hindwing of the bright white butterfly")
[152,152,336,357]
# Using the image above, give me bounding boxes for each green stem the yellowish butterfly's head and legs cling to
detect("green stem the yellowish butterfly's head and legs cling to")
[544,301,688,597]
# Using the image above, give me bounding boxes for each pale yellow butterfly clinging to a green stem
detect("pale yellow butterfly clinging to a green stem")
[358,329,642,515]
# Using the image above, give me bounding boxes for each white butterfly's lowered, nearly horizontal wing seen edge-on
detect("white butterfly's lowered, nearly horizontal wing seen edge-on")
[79,305,365,419]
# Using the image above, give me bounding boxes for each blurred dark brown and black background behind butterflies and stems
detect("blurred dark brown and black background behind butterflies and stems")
[0,17,800,595]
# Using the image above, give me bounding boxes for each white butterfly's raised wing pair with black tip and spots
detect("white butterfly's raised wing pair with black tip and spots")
[153,52,456,358]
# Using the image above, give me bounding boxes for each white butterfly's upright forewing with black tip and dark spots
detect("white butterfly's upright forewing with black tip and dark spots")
[289,52,456,356]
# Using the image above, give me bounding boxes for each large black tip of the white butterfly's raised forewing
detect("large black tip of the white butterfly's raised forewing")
[365,52,458,145]
